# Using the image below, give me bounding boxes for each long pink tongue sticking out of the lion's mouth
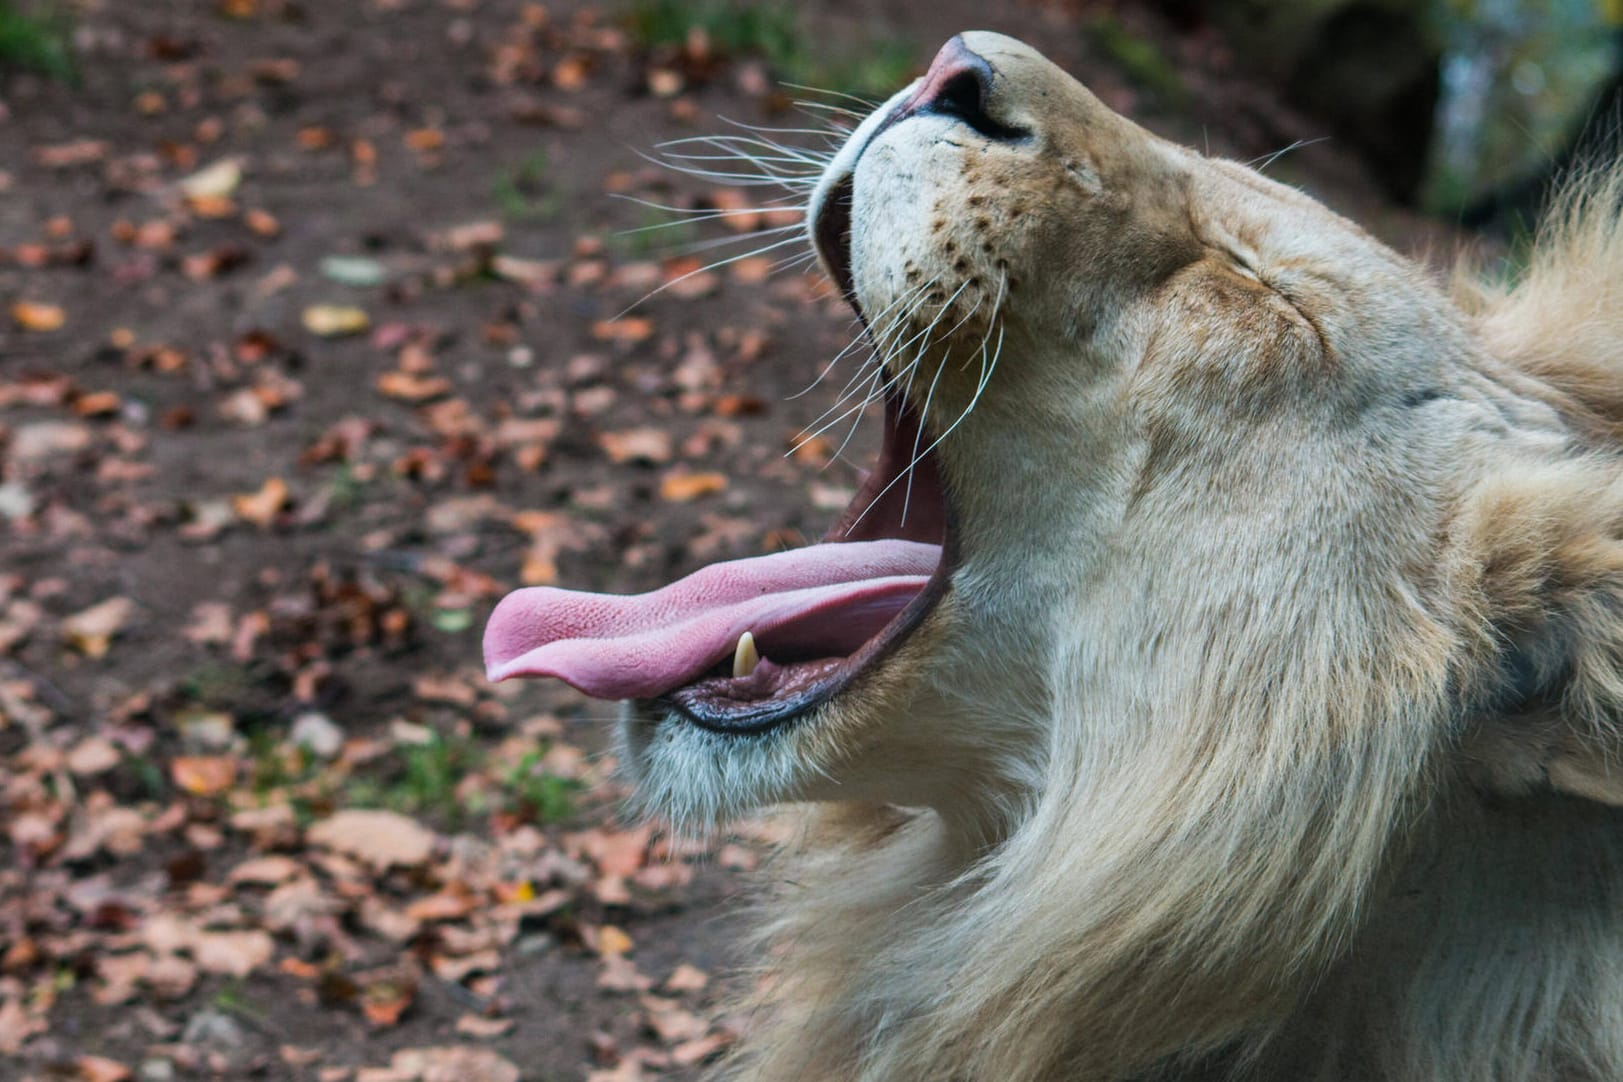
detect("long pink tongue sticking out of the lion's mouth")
[485,540,941,699]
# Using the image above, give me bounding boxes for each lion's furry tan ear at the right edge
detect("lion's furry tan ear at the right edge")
[1451,459,1623,806]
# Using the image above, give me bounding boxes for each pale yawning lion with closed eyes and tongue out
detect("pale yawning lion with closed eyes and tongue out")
[485,32,1623,1082]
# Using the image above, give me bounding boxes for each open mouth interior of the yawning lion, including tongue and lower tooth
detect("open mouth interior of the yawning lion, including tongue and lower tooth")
[473,399,948,732]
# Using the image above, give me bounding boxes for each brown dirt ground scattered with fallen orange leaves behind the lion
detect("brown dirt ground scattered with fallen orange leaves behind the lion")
[0,0,1446,1082]
